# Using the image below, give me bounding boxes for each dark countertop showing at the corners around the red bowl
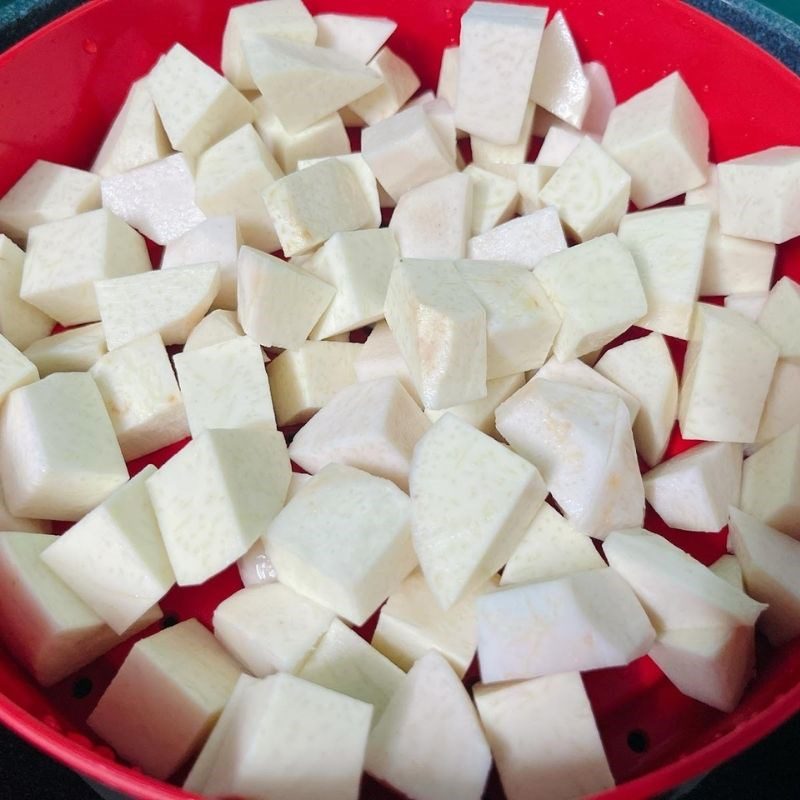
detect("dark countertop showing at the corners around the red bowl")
[0,0,800,800]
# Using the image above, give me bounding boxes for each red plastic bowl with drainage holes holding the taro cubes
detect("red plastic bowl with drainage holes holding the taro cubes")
[0,0,800,800]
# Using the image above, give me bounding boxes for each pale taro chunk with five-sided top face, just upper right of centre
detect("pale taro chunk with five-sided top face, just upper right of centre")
[533,234,647,361]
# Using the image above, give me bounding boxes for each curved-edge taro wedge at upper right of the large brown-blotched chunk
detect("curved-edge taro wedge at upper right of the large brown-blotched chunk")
[594,333,678,466]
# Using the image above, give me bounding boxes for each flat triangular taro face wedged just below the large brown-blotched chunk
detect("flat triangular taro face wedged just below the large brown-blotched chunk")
[500,503,606,586]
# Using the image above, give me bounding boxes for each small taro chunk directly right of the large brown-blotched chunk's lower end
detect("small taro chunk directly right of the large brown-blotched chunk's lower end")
[643,442,742,533]
